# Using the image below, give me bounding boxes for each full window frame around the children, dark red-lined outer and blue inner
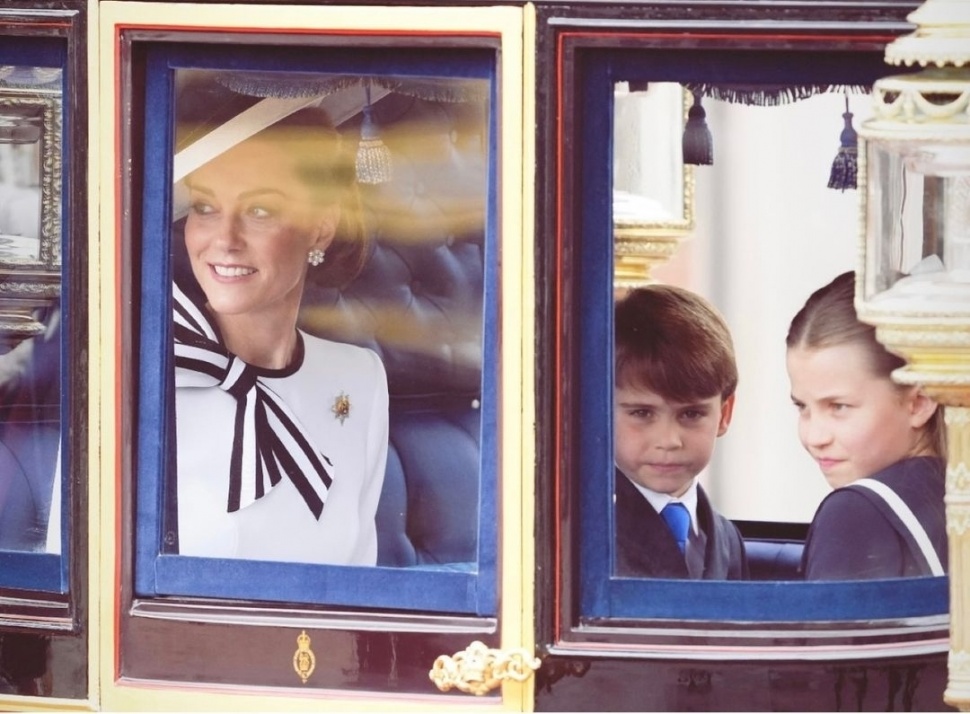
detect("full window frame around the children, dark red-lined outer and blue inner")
[539,17,948,658]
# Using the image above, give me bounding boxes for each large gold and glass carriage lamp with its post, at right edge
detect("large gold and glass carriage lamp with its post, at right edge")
[856,0,970,710]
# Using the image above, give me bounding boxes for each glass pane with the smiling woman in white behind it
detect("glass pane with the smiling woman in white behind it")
[162,70,489,568]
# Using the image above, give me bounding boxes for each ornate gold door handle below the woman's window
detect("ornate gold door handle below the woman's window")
[428,641,541,696]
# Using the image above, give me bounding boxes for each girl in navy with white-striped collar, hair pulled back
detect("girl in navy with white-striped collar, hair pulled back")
[786,272,947,580]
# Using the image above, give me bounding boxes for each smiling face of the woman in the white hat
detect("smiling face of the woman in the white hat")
[185,136,338,318]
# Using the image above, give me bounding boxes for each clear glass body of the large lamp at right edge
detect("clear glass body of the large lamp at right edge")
[865,141,970,311]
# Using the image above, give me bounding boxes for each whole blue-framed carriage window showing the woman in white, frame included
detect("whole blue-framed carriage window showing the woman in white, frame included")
[135,47,497,615]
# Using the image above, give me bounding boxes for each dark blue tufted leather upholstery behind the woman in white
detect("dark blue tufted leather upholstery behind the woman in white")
[301,94,486,568]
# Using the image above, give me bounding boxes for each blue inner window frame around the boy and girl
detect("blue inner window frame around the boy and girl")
[567,48,948,624]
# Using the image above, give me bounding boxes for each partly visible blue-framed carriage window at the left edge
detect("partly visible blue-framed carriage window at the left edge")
[0,36,74,594]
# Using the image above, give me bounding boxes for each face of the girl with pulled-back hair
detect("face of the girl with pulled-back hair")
[787,344,936,488]
